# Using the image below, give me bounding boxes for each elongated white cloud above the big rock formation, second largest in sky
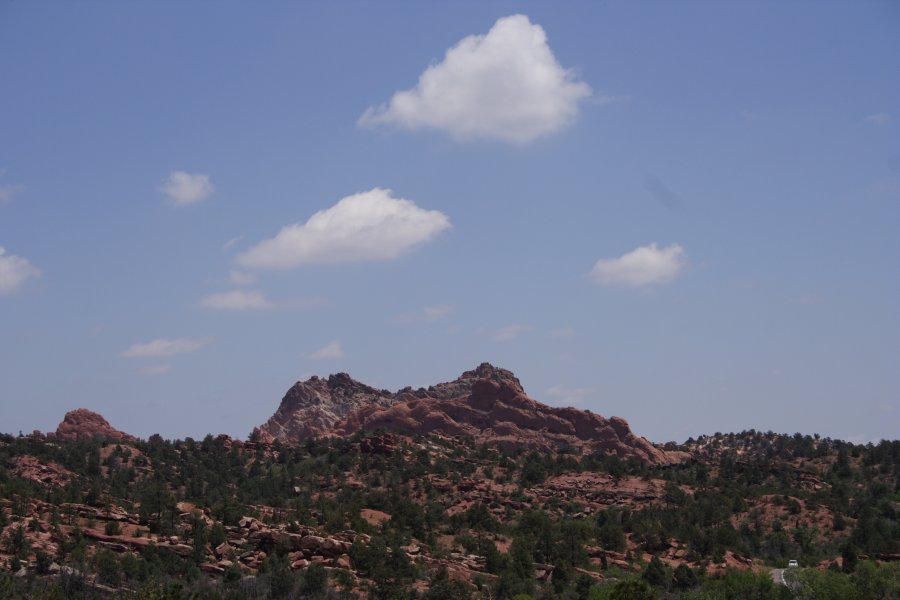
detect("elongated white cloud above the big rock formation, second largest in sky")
[236,188,450,269]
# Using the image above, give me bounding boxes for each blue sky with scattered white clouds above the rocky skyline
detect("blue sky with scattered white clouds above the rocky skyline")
[0,1,900,441]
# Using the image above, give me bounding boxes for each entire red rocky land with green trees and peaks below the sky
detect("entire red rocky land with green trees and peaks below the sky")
[0,364,900,600]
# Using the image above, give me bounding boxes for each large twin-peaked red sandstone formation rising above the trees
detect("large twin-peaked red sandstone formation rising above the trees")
[258,363,684,465]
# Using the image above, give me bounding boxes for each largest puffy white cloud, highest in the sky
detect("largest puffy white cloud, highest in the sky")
[359,15,591,143]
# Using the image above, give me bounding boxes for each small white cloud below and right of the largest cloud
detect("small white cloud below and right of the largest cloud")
[590,243,687,287]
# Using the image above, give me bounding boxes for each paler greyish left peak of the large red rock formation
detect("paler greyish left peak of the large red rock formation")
[257,373,394,442]
